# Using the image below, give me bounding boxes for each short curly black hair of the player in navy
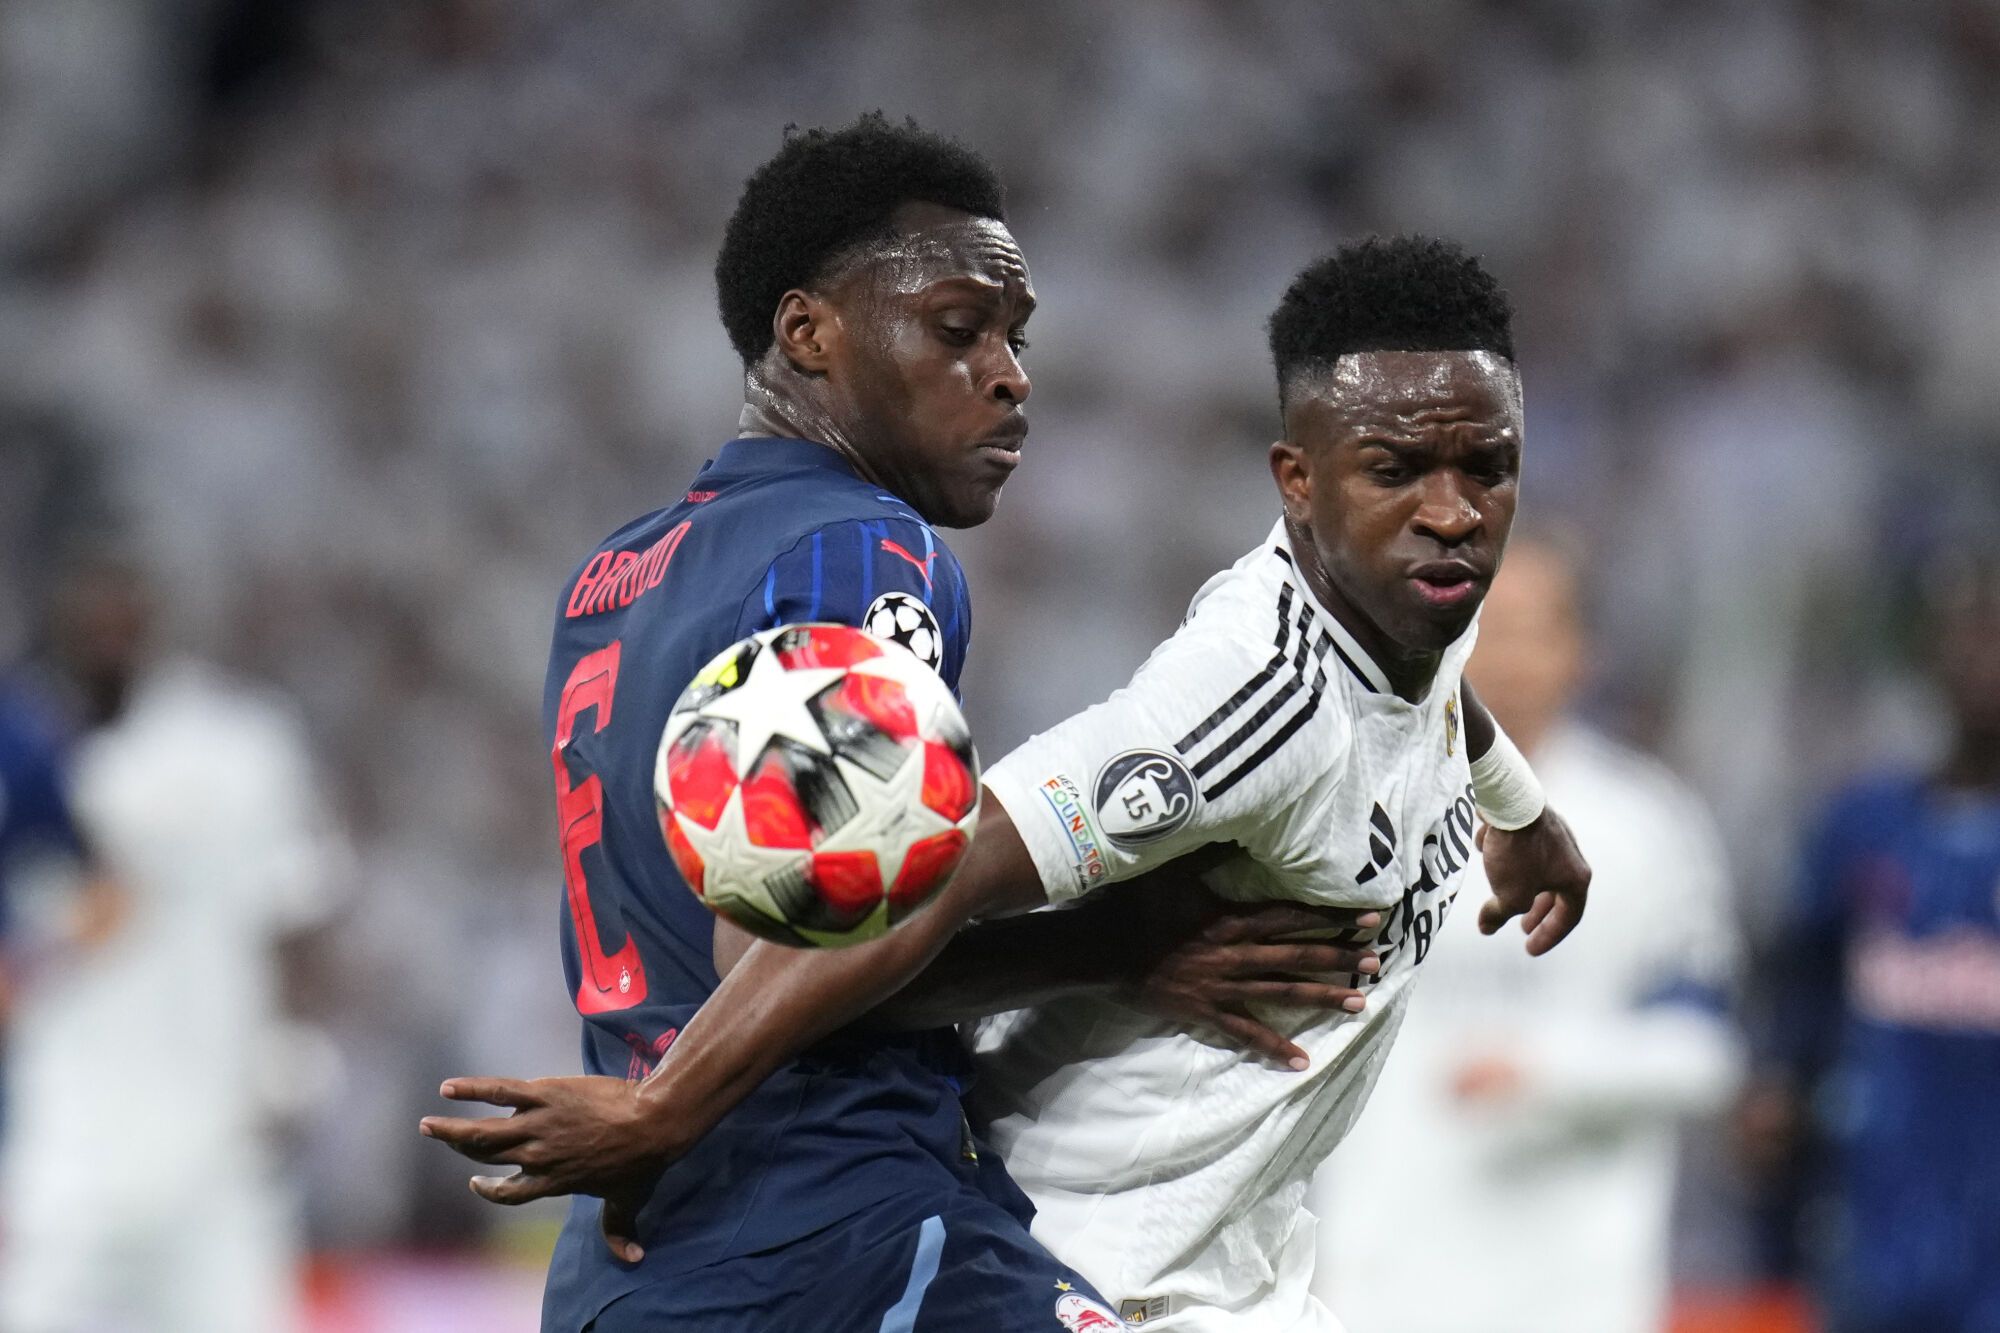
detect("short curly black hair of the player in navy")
[716,112,1006,366]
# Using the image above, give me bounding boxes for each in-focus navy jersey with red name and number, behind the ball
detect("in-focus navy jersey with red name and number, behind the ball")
[544,438,1000,1311]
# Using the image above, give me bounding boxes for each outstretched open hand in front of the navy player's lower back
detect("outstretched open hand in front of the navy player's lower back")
[420,1075,678,1263]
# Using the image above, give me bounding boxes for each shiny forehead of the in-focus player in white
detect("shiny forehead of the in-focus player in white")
[1286,350,1522,442]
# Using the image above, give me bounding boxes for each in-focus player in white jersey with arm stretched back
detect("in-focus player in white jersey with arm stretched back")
[428,238,1588,1333]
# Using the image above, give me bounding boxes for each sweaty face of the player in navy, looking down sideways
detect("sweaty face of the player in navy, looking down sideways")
[828,204,1034,528]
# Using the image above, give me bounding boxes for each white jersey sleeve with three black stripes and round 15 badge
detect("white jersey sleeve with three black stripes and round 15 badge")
[986,580,1348,903]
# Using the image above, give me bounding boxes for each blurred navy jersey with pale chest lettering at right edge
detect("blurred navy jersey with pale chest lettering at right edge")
[1770,773,2000,1329]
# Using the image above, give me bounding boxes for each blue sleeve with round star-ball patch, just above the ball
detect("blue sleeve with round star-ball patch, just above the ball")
[736,514,972,693]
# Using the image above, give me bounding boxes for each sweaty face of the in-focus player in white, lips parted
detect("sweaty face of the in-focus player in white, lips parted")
[1270,352,1522,677]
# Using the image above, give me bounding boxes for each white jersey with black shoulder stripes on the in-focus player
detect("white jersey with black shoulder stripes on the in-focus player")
[972,522,1476,1333]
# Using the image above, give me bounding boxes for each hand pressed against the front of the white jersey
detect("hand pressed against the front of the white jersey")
[1120,891,1382,1069]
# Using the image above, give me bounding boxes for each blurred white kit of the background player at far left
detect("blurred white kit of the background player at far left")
[0,662,340,1333]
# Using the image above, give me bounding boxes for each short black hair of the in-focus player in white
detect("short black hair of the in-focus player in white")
[1270,236,1514,402]
